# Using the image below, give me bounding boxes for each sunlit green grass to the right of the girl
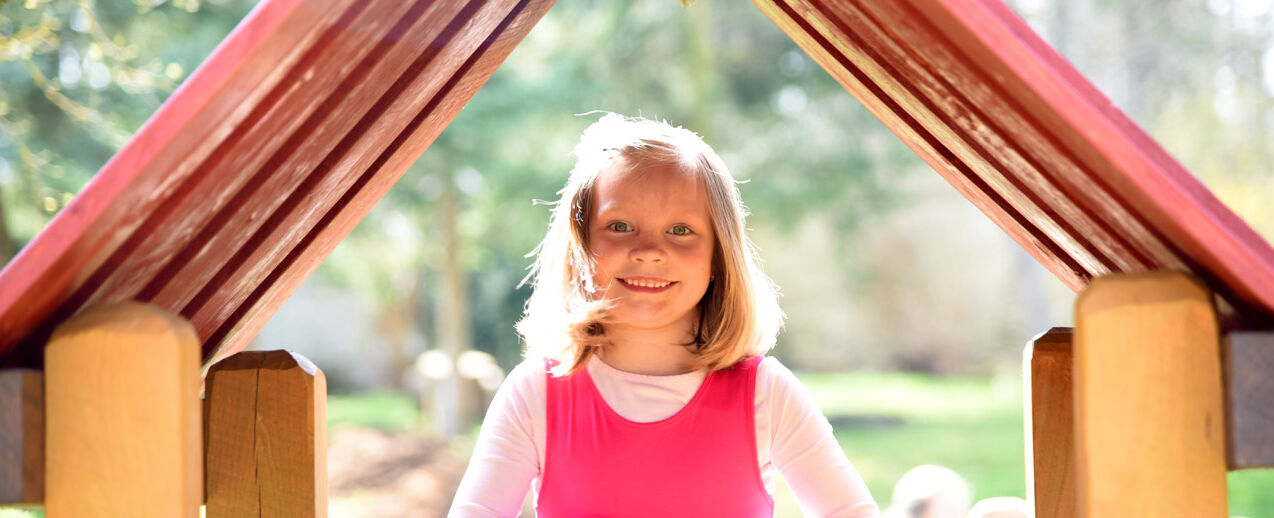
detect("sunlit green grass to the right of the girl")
[776,373,1274,518]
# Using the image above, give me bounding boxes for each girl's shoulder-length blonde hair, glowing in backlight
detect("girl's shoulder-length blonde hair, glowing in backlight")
[517,113,784,375]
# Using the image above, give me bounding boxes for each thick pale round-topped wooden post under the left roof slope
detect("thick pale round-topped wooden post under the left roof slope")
[45,303,203,518]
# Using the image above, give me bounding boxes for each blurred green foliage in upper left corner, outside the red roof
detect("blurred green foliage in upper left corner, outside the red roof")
[0,0,252,254]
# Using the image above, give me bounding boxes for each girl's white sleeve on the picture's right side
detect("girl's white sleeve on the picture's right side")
[757,358,880,518]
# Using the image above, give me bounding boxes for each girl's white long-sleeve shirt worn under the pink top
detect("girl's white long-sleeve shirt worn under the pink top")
[448,356,880,518]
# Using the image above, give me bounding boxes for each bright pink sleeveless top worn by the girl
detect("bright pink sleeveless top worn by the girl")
[536,356,775,518]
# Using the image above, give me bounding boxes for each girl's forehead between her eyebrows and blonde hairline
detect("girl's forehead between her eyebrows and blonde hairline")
[592,159,708,218]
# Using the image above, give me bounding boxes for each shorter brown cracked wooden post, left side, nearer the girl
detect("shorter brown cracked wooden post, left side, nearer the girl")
[204,351,327,518]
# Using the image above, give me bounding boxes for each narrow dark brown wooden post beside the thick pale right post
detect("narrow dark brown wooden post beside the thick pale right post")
[1023,327,1075,518]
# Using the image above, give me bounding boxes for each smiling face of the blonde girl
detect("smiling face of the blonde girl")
[589,159,716,332]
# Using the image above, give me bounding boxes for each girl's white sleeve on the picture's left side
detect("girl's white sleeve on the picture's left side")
[447,361,545,517]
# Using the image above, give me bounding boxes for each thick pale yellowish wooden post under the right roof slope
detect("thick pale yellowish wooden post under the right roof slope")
[1074,271,1227,518]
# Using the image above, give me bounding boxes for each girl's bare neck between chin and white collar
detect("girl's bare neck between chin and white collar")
[599,325,694,375]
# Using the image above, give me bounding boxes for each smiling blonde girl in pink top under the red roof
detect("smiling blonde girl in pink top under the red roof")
[450,113,879,517]
